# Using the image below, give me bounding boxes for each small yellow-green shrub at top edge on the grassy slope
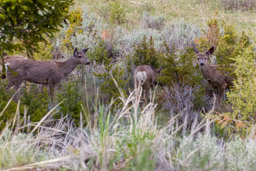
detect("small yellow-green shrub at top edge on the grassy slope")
[109,0,125,24]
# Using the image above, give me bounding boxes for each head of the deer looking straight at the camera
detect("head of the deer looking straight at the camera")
[193,44,214,68]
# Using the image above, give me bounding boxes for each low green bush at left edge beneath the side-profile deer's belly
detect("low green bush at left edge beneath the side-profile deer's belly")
[0,81,49,130]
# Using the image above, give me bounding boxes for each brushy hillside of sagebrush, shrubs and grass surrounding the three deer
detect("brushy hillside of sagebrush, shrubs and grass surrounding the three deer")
[0,0,256,171]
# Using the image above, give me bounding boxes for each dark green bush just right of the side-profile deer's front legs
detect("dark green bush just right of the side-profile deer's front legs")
[54,81,83,126]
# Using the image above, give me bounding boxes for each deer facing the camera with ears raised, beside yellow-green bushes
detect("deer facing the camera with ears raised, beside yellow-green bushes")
[193,44,233,107]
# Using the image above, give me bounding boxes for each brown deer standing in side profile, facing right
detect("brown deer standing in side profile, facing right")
[3,48,90,103]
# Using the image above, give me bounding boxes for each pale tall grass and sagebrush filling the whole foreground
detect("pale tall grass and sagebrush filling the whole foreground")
[0,86,256,170]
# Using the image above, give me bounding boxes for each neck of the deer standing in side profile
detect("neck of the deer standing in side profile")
[56,57,78,77]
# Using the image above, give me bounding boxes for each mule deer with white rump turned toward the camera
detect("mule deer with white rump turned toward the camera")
[133,65,161,100]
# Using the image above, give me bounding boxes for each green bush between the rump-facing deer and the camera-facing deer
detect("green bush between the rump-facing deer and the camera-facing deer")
[159,43,205,109]
